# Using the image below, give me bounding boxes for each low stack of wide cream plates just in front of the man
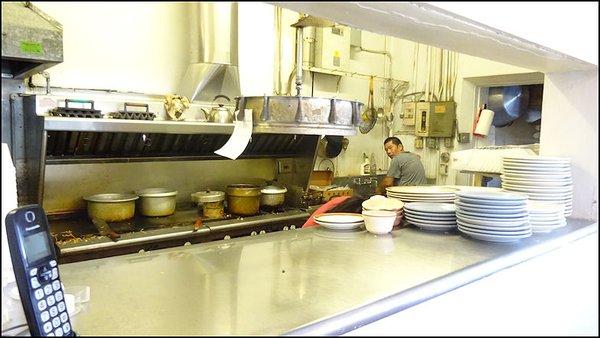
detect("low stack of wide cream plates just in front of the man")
[386,185,458,203]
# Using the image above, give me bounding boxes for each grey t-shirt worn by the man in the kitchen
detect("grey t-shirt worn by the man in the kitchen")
[387,151,427,185]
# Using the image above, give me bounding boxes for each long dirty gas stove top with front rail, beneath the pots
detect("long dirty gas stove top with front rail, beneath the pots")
[49,206,310,263]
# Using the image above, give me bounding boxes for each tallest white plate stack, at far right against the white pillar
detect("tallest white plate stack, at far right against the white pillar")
[500,155,573,216]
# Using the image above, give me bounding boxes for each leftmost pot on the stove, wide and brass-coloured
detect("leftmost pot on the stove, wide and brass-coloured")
[83,194,139,222]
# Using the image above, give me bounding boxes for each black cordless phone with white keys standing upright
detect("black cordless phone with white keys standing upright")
[6,204,75,336]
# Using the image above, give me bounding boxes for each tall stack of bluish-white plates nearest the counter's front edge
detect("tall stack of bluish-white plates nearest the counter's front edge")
[458,191,532,242]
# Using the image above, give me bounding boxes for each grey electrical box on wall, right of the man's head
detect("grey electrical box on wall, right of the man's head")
[415,101,456,137]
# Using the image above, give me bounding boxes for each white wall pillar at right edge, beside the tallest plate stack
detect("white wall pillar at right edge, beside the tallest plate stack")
[540,71,598,219]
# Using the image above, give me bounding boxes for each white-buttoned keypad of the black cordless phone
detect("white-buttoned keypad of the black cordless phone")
[29,260,72,336]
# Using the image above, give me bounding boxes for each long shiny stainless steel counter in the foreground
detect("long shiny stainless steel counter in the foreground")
[60,219,597,336]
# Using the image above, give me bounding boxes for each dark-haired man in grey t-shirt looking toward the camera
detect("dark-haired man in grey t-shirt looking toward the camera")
[375,137,427,195]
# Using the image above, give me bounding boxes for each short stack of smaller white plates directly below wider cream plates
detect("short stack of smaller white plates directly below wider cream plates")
[404,202,456,231]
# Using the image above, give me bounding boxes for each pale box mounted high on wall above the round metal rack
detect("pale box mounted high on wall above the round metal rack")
[315,26,350,71]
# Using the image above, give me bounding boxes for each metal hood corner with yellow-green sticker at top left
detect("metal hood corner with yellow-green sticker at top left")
[2,2,63,78]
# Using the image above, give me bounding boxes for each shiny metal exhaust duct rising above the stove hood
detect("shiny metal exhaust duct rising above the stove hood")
[180,2,240,101]
